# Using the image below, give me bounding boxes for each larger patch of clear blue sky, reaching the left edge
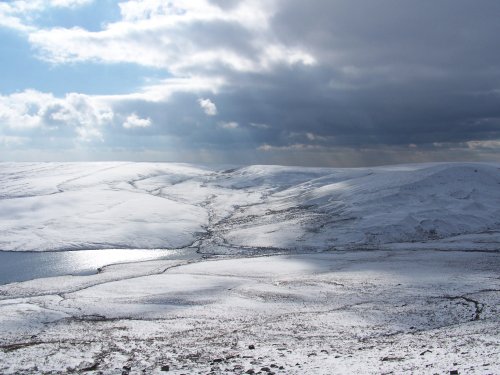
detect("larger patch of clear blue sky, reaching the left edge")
[0,28,169,96]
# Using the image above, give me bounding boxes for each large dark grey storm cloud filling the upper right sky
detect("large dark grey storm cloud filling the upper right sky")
[234,1,500,150]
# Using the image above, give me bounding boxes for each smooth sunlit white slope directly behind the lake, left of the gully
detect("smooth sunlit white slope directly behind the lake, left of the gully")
[0,163,206,251]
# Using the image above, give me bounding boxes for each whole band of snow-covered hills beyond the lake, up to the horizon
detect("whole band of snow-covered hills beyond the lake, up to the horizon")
[0,163,500,253]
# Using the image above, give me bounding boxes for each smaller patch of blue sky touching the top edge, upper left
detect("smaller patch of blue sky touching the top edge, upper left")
[34,0,120,31]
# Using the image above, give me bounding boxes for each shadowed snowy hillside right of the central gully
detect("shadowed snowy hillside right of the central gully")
[221,164,500,249]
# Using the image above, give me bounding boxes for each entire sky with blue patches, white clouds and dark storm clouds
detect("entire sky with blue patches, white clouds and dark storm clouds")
[0,0,500,167]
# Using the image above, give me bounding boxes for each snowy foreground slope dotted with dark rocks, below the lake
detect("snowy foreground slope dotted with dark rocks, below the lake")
[0,250,500,375]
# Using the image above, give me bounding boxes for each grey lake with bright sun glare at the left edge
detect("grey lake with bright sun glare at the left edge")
[0,249,188,284]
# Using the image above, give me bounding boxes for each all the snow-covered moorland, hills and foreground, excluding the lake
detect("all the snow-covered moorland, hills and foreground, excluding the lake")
[0,163,500,374]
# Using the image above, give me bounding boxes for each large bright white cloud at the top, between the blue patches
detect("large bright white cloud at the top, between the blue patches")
[25,0,316,76]
